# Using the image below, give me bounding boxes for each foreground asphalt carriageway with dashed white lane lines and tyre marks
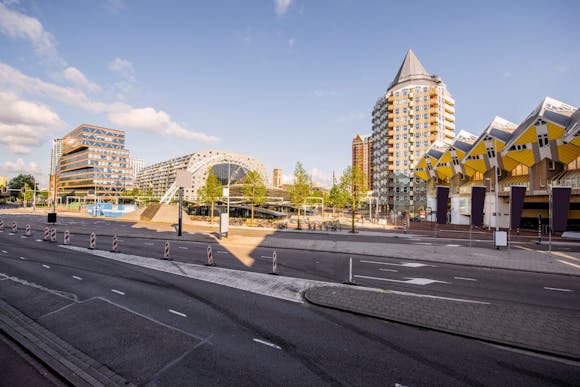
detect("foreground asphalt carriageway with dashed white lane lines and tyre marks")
[0,227,580,386]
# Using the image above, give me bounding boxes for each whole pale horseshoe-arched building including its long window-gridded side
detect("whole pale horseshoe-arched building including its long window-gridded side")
[136,150,269,203]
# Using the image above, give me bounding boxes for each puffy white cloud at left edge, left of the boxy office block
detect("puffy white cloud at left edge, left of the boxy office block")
[0,92,64,154]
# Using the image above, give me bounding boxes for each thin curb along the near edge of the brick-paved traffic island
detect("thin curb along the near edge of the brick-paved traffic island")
[304,288,580,361]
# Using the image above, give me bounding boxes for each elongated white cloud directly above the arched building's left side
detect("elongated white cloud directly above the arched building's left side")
[109,106,219,143]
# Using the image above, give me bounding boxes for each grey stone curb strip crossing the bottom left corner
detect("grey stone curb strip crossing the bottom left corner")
[0,299,134,386]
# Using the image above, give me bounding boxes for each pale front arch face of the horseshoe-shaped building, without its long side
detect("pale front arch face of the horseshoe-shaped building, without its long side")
[161,150,270,203]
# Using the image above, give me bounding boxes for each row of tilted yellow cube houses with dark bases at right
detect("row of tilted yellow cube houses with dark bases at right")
[413,97,580,231]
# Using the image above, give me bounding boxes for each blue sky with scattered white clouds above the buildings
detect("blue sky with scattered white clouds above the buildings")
[0,0,580,186]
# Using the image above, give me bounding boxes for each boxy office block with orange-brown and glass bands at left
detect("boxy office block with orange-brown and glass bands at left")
[57,124,132,201]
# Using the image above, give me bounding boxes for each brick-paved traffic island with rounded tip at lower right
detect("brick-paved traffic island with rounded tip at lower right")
[305,286,580,360]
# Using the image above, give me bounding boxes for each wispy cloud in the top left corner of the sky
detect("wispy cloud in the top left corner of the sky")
[0,3,64,65]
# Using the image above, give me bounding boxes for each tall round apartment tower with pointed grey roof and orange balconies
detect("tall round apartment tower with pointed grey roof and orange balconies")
[372,49,455,215]
